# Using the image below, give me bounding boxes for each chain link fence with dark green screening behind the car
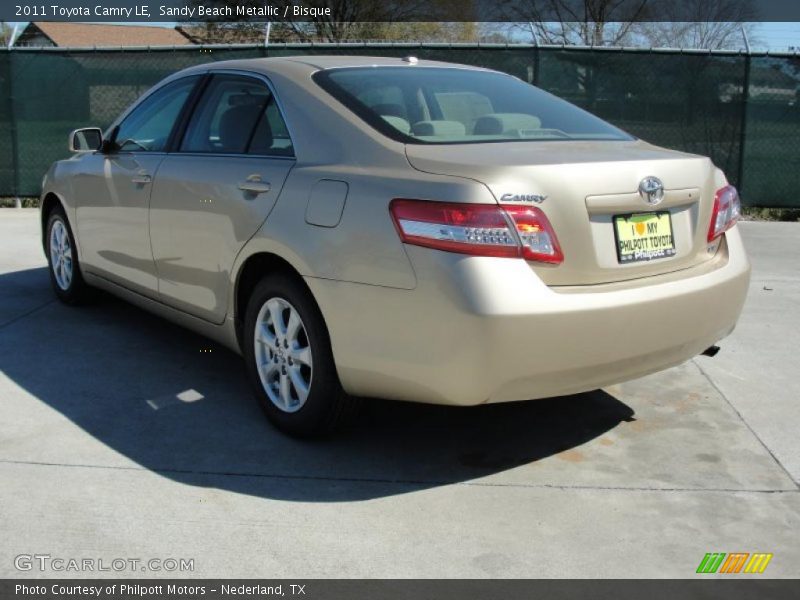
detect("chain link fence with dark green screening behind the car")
[0,44,800,208]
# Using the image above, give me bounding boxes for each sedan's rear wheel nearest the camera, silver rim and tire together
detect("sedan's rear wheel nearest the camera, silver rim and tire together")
[243,275,354,437]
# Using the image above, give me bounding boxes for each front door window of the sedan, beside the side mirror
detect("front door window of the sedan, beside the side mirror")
[115,76,199,152]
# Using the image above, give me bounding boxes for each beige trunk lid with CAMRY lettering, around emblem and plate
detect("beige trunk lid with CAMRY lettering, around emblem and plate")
[406,140,717,286]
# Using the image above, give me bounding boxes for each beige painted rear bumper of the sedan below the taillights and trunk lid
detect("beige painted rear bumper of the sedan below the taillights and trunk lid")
[307,228,750,405]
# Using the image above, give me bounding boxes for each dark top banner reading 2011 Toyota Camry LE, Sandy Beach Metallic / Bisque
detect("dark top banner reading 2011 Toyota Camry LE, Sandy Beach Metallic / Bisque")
[0,0,800,23]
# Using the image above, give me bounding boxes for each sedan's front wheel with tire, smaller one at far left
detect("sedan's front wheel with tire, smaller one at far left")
[45,207,89,304]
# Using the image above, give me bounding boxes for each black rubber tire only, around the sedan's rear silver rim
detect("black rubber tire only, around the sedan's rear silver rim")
[242,274,356,438]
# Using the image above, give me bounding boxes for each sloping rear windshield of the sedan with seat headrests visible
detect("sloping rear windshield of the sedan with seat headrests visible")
[314,66,633,144]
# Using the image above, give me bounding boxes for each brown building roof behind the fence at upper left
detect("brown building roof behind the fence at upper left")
[20,21,192,48]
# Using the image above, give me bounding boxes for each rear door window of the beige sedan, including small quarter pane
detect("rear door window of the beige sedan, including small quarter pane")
[180,75,294,156]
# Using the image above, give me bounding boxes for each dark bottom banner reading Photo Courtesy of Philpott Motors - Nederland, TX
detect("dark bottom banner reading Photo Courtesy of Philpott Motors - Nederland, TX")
[0,575,800,600]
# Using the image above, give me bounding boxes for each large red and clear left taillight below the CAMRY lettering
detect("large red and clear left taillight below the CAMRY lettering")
[389,199,564,264]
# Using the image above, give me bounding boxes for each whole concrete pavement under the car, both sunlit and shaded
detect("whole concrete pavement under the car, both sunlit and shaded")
[0,209,800,578]
